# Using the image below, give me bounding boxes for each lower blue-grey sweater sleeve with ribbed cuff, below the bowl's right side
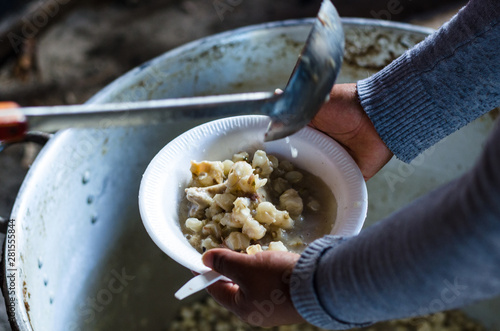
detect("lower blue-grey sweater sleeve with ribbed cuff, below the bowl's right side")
[290,120,500,329]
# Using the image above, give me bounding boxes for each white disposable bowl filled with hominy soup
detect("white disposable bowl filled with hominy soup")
[139,115,368,273]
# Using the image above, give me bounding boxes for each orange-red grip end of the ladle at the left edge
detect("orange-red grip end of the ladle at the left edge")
[0,102,28,142]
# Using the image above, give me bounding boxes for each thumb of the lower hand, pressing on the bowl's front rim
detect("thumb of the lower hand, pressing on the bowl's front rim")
[202,248,251,283]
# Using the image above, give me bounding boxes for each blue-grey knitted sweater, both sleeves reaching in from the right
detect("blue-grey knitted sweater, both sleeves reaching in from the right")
[290,0,500,329]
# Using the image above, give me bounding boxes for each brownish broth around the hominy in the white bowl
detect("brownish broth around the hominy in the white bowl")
[180,153,337,253]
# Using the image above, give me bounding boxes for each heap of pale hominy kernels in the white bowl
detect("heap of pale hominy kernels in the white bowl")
[184,150,322,254]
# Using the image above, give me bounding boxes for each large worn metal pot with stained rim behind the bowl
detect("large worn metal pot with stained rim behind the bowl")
[3,19,500,331]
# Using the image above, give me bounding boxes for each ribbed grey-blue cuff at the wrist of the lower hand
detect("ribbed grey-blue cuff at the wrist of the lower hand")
[290,235,368,330]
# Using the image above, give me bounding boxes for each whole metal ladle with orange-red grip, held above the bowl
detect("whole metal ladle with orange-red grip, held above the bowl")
[0,0,344,142]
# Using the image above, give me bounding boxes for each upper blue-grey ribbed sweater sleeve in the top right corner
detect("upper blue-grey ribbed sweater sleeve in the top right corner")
[358,0,500,162]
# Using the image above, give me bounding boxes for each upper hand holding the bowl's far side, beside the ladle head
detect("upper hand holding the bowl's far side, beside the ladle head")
[310,84,393,180]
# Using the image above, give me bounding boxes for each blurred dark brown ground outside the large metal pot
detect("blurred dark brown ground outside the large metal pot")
[0,0,464,330]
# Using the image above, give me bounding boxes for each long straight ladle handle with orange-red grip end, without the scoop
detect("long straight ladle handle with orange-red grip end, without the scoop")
[0,92,279,142]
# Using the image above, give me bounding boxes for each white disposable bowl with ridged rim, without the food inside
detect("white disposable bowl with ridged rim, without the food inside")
[139,116,368,273]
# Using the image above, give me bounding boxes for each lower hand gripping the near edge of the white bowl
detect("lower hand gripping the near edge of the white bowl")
[203,248,304,327]
